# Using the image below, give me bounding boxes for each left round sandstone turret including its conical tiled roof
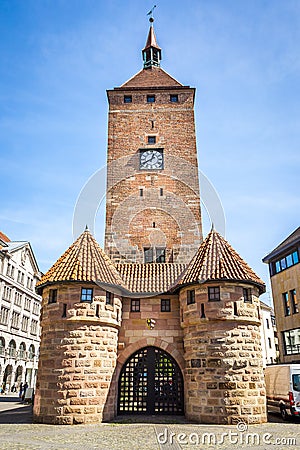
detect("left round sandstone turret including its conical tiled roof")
[34,230,122,424]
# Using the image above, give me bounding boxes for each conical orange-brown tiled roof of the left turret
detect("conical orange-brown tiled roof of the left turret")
[39,229,124,287]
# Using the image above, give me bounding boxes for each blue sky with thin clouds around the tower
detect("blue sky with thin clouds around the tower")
[0,0,300,300]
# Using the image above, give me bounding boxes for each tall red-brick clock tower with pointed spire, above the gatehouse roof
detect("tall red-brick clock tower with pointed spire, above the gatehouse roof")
[105,18,202,263]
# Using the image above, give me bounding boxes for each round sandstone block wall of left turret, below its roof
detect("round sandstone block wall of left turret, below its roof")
[34,283,122,424]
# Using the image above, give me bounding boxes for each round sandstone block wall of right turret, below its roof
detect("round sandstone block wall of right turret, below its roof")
[180,283,267,424]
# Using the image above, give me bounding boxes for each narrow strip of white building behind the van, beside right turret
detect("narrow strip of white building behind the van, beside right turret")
[260,301,279,367]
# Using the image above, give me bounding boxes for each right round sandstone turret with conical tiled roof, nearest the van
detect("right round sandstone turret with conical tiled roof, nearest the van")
[179,230,267,424]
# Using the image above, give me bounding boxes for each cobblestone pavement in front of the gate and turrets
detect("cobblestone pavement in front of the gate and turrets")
[0,398,300,450]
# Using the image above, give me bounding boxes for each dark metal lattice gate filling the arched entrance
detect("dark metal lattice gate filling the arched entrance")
[118,347,184,415]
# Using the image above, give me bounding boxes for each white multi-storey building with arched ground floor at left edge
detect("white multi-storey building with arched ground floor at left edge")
[0,232,41,391]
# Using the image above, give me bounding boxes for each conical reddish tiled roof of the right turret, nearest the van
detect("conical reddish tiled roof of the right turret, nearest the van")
[178,230,265,293]
